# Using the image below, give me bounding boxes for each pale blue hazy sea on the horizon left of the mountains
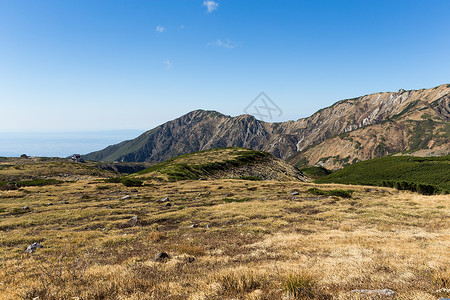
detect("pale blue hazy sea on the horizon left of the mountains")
[0,130,143,157]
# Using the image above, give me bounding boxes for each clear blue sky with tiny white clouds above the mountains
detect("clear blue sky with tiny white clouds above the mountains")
[0,0,450,132]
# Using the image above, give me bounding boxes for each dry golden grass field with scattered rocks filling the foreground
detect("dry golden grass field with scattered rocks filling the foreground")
[0,159,450,299]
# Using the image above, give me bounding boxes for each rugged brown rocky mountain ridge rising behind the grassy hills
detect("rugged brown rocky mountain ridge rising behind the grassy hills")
[84,85,450,169]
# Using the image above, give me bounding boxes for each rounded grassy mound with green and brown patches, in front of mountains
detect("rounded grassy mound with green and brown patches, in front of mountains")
[132,147,304,181]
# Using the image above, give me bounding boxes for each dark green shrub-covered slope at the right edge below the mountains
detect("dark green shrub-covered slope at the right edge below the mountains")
[316,155,450,194]
